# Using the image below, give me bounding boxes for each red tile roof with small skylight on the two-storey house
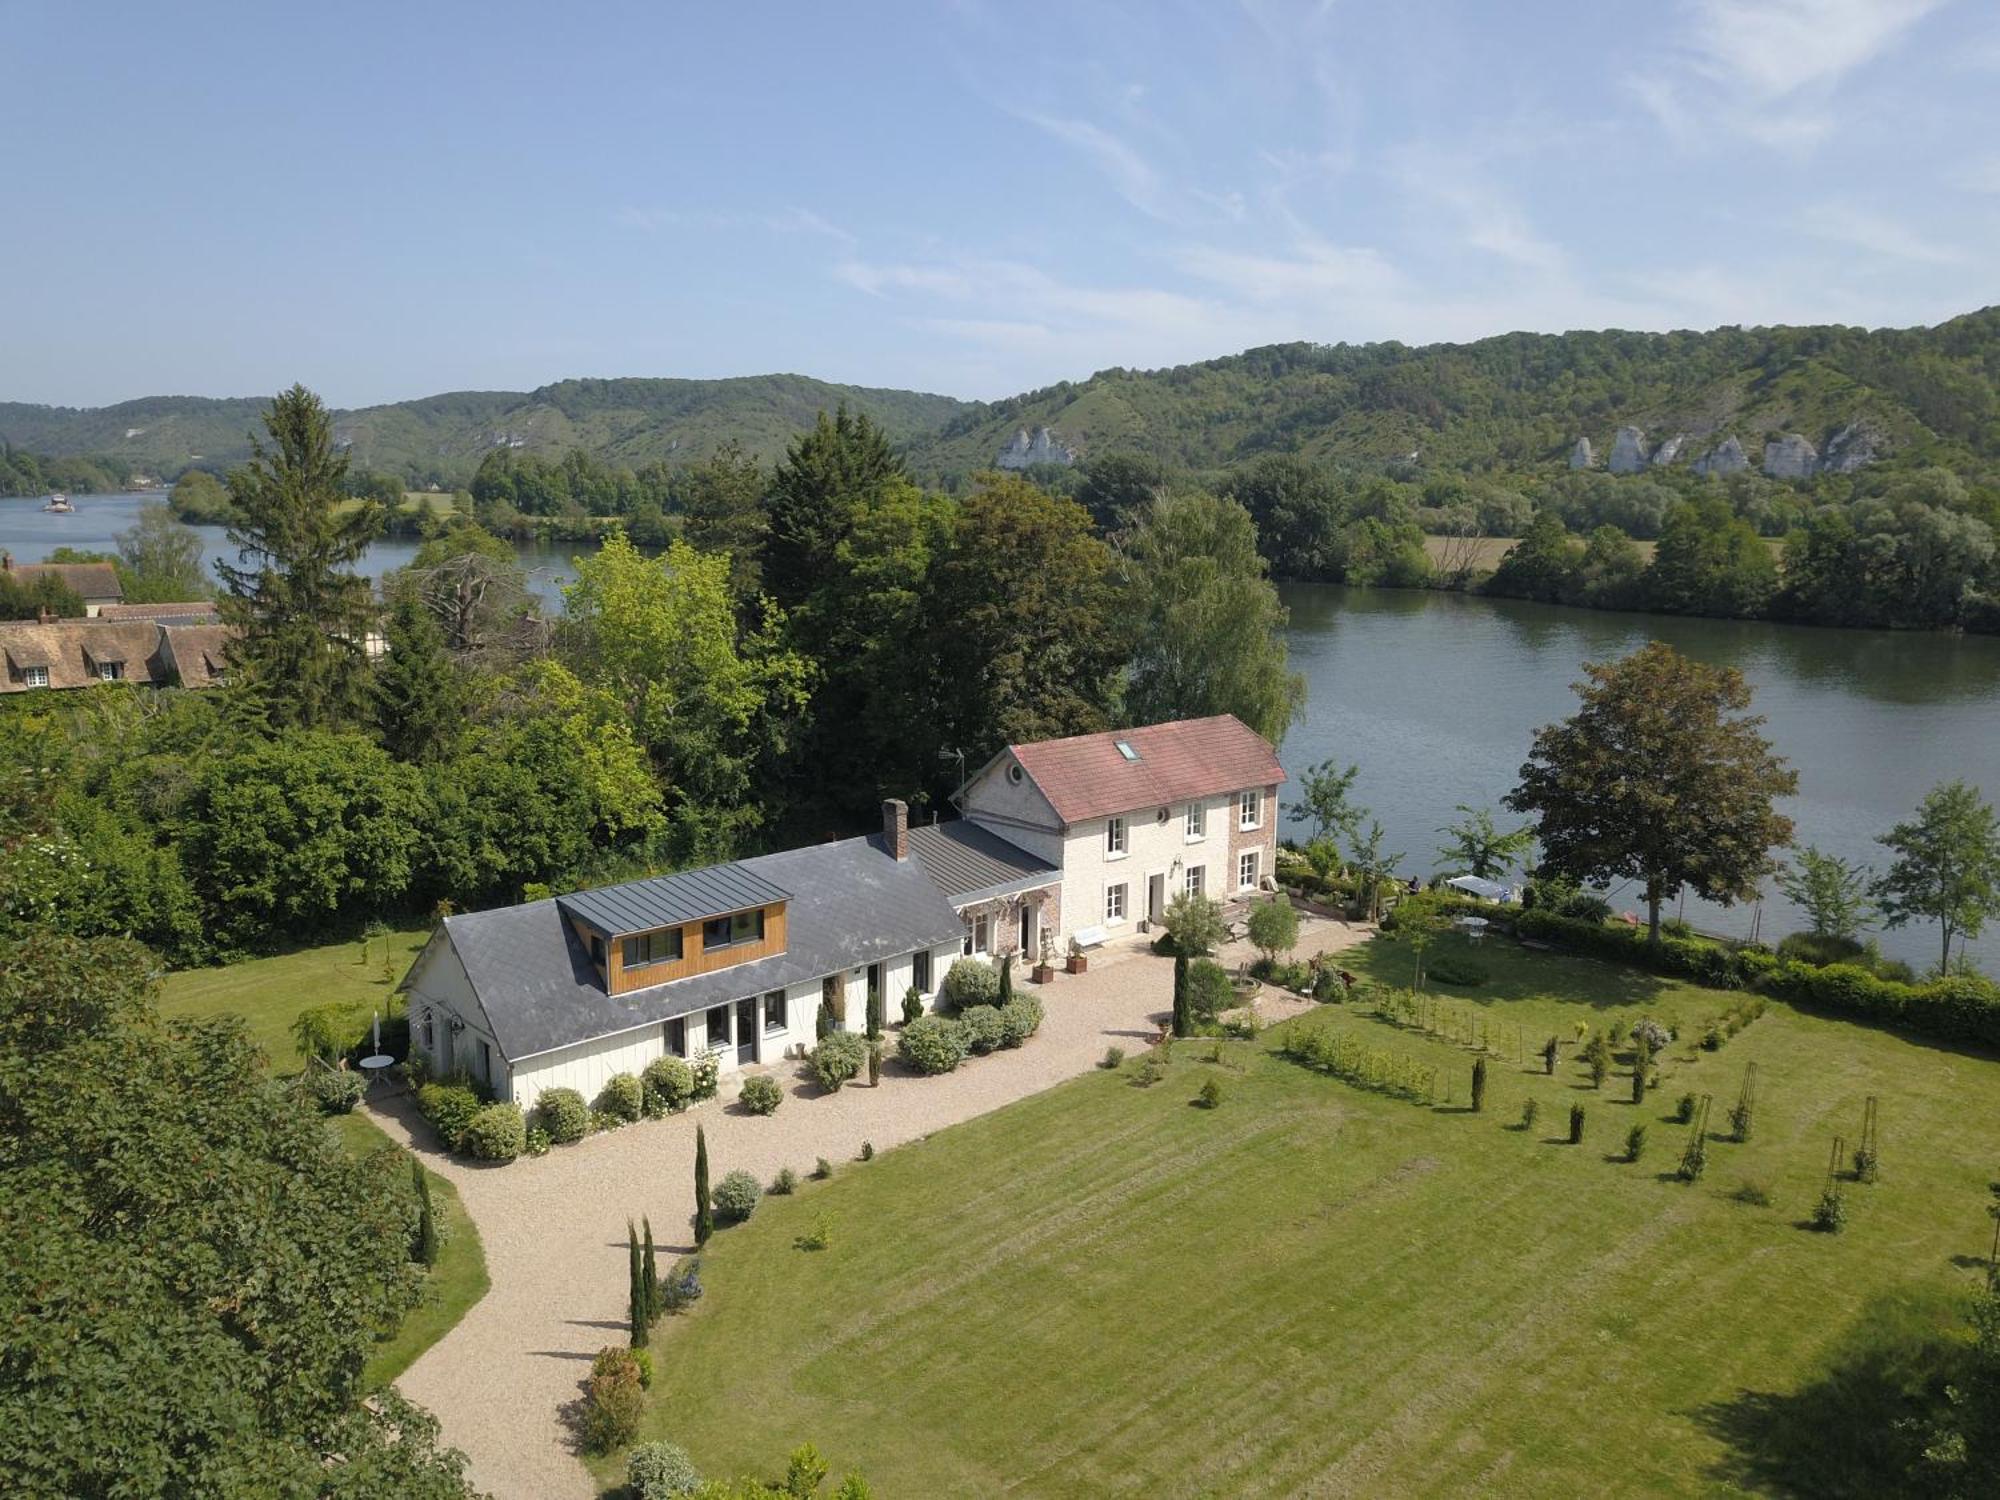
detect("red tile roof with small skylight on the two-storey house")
[1008,714,1284,822]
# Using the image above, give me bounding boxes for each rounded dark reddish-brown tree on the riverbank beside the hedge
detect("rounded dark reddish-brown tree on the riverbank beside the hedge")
[1506,642,1798,942]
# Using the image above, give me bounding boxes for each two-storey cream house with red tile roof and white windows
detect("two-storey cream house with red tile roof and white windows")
[960,714,1284,936]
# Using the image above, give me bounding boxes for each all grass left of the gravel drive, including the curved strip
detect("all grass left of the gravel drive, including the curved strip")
[160,926,490,1388]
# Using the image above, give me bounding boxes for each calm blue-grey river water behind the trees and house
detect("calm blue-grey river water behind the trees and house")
[0,496,2000,972]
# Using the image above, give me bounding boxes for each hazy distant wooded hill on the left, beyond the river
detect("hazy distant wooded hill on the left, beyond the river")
[0,374,964,482]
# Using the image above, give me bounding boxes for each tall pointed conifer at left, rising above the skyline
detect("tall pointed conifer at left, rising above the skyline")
[216,386,382,728]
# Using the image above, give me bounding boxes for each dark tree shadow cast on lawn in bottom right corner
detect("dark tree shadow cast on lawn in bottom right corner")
[1692,1288,1966,1496]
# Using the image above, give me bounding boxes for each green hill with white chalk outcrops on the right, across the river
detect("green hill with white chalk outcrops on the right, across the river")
[918,308,2000,484]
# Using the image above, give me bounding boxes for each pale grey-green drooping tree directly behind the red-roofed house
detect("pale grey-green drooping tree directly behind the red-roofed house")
[1124,494,1306,744]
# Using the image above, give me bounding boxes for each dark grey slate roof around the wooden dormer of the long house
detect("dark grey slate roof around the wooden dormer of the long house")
[444,834,964,1062]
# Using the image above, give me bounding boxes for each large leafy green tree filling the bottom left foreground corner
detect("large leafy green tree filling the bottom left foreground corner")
[0,934,466,1500]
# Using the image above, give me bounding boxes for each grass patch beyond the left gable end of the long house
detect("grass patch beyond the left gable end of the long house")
[160,926,430,1072]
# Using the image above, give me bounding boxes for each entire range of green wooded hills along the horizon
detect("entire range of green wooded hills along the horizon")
[0,308,2000,482]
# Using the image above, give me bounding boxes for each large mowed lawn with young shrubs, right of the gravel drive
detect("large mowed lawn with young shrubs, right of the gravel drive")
[598,940,2000,1496]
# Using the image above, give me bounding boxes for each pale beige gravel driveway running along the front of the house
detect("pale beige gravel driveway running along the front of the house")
[366,916,1368,1500]
